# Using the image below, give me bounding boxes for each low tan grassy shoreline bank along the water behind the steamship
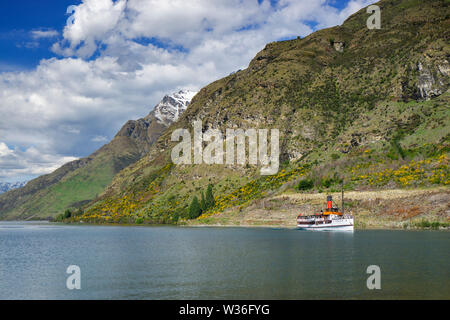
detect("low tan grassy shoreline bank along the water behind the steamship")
[0,186,450,231]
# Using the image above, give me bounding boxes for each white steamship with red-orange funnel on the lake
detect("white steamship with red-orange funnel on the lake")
[297,192,353,231]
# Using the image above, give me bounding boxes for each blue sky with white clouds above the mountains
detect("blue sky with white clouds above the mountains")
[0,0,374,181]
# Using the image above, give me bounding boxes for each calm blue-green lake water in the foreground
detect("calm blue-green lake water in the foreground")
[0,222,450,299]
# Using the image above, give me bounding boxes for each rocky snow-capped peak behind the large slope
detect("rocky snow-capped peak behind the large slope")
[154,90,197,126]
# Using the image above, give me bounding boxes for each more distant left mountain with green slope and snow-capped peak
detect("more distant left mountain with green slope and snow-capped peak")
[0,91,195,219]
